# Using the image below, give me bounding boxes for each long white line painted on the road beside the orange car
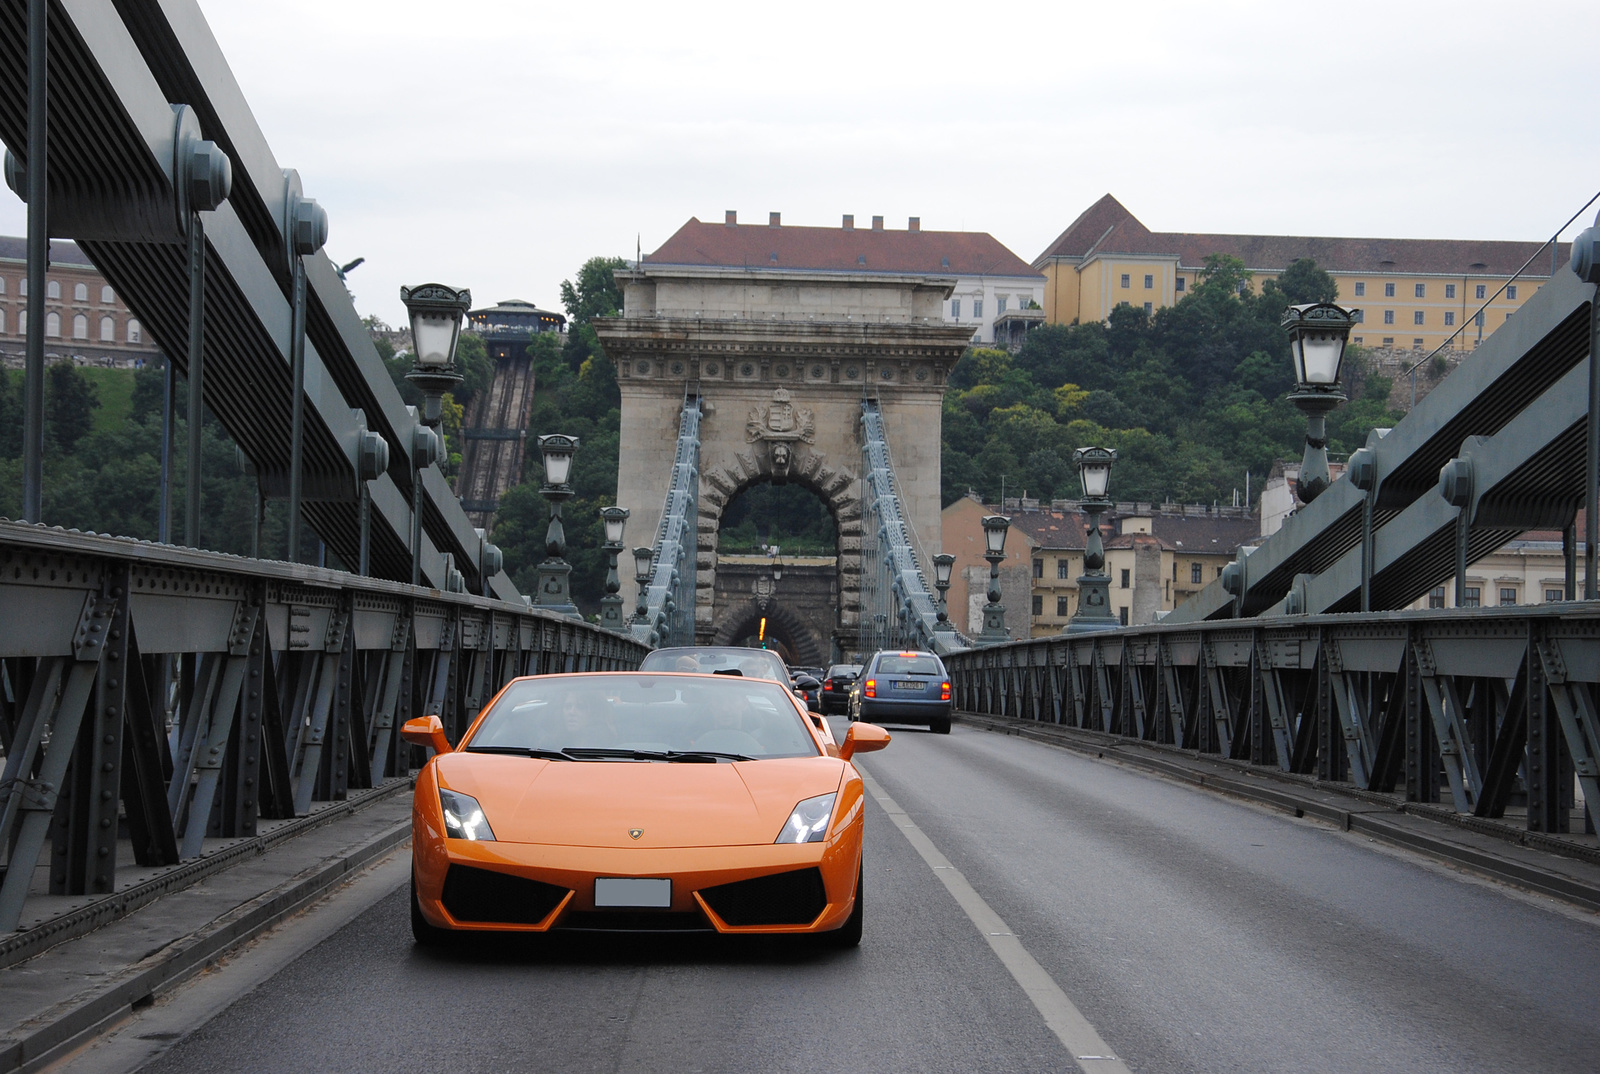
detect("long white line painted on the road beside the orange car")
[856,763,1133,1074]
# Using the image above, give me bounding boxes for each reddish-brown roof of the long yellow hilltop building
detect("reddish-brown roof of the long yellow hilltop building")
[1034,194,1571,277]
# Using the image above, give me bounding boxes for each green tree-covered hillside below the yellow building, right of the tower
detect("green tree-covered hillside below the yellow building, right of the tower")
[942,258,1398,504]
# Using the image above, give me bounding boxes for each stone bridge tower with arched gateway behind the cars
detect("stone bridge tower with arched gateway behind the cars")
[595,214,1010,663]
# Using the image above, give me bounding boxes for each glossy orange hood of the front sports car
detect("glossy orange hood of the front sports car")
[437,754,845,847]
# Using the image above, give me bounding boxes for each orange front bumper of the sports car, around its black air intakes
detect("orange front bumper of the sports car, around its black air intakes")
[413,823,861,933]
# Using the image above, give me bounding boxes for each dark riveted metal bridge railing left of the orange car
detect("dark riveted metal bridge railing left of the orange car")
[0,520,646,932]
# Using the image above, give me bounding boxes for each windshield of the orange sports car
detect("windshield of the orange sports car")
[466,672,818,760]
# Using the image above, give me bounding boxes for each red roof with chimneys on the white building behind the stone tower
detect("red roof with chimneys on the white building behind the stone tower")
[645,218,1042,280]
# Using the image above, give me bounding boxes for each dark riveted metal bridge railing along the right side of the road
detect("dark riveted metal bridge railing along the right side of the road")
[946,602,1600,832]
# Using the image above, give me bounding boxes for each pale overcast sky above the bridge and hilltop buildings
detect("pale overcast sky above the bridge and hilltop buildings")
[0,0,1600,323]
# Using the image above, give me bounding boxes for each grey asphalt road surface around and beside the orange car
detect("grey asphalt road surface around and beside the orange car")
[93,727,1600,1074]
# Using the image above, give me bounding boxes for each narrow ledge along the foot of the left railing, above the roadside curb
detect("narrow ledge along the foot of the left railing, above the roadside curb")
[0,778,413,973]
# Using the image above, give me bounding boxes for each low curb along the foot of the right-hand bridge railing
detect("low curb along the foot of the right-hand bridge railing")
[955,712,1600,911]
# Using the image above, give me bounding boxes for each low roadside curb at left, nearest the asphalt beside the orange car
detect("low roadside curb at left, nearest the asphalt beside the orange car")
[0,816,411,1074]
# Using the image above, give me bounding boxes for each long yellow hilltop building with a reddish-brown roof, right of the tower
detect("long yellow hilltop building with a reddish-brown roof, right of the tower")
[1034,194,1570,351]
